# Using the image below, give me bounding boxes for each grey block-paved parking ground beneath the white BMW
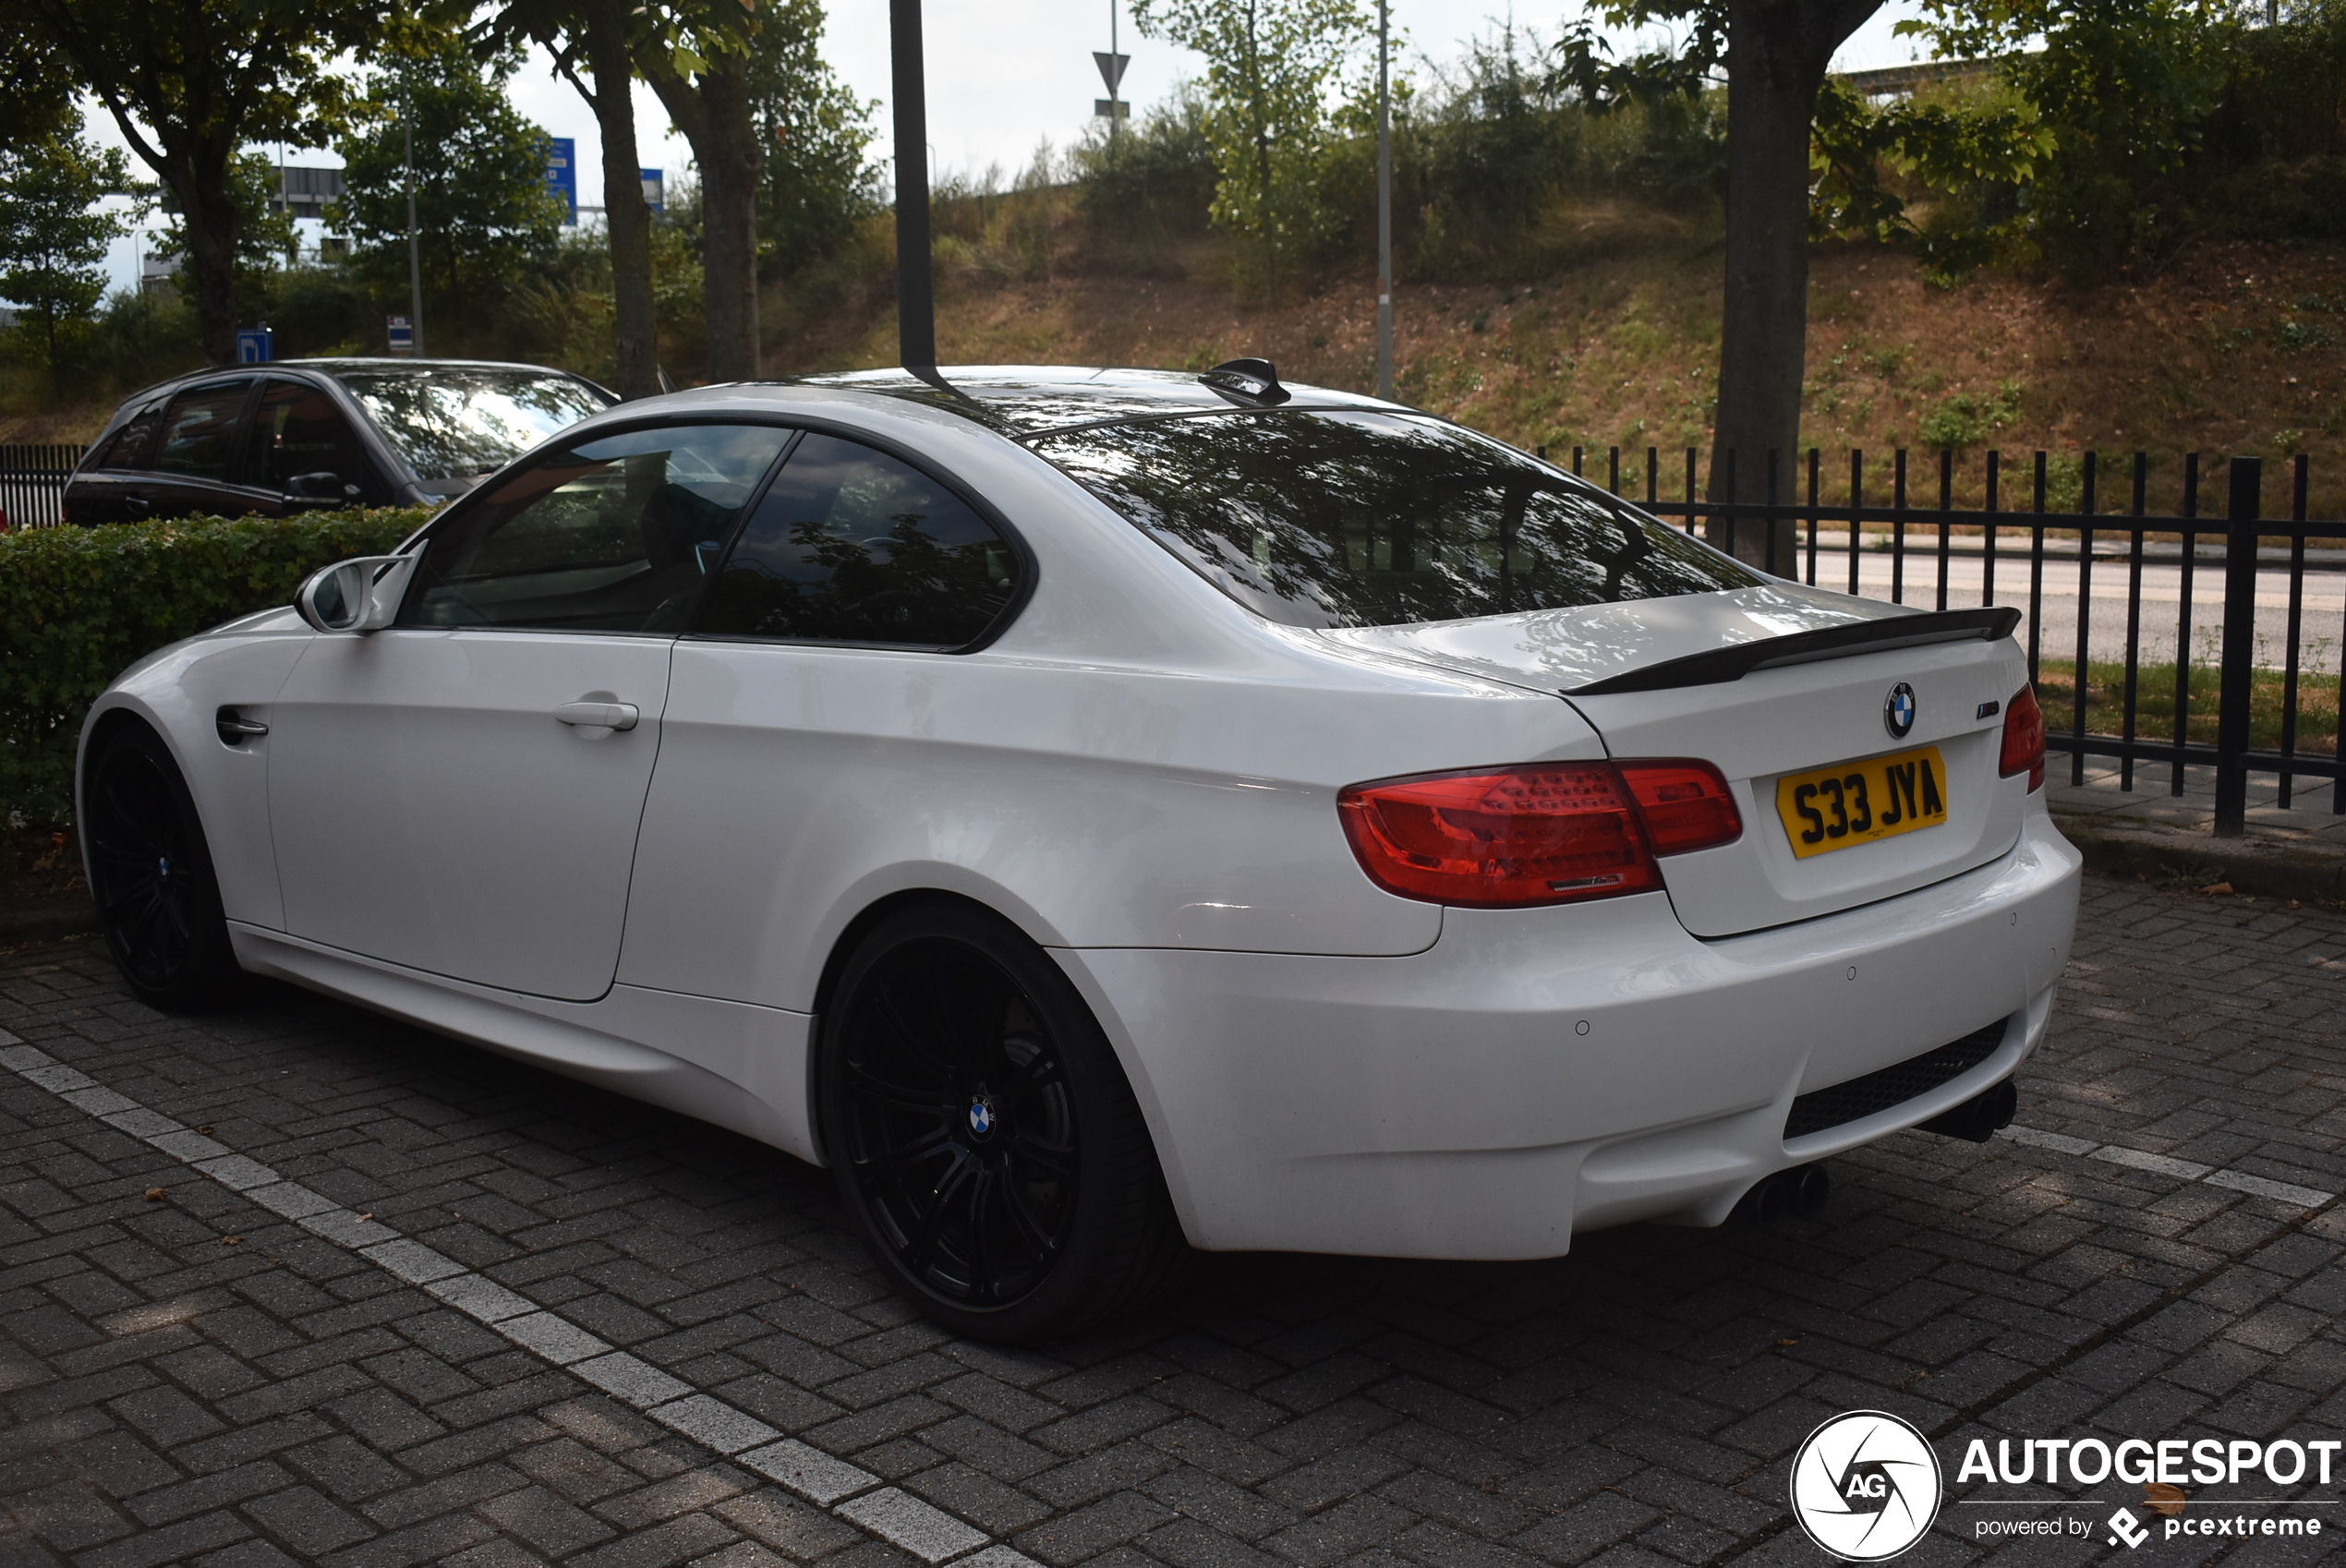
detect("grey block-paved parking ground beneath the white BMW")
[0,881,2346,1568]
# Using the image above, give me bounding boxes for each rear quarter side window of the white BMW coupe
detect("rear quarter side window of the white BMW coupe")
[695,434,1018,647]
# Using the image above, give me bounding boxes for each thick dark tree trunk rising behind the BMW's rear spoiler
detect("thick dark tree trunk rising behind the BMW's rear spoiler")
[1708,0,1881,574]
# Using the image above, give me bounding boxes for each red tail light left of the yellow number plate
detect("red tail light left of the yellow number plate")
[1337,762,1743,910]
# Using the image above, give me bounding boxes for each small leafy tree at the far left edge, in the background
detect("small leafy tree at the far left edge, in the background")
[0,108,131,393]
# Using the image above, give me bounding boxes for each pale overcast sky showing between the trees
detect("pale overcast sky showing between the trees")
[90,0,1917,288]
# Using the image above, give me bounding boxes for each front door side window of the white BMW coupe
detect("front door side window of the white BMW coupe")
[399,424,791,631]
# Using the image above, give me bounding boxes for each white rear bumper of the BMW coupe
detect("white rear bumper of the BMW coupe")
[1060,802,2081,1259]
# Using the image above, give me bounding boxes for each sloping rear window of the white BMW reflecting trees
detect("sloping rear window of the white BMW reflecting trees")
[1034,413,1767,626]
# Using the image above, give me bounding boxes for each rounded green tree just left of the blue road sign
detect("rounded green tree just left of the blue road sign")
[333,30,563,332]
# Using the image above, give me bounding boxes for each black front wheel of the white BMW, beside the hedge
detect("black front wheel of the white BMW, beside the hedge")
[82,722,247,1012]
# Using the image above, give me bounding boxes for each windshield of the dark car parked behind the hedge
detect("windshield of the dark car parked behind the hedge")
[335,366,610,480]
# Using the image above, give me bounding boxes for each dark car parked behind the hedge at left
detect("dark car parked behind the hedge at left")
[66,358,620,525]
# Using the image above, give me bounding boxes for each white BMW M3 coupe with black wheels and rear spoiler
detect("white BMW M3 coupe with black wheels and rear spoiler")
[78,361,2078,1338]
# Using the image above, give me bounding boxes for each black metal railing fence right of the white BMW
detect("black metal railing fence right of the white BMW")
[1542,448,2346,835]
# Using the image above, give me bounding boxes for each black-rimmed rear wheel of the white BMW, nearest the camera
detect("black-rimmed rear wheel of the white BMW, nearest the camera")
[816,905,1190,1343]
